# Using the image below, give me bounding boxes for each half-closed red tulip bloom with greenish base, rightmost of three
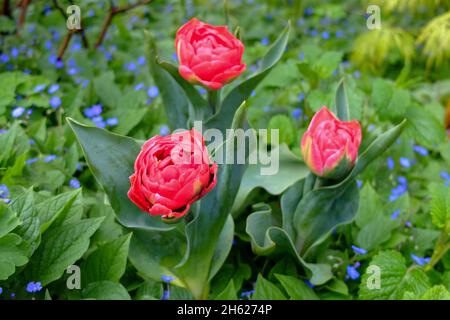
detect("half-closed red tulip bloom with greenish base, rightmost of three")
[301,107,361,179]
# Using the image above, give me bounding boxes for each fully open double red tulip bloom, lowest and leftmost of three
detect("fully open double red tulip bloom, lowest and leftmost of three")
[128,129,217,219]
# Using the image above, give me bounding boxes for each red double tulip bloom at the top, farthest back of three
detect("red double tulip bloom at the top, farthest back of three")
[175,18,246,90]
